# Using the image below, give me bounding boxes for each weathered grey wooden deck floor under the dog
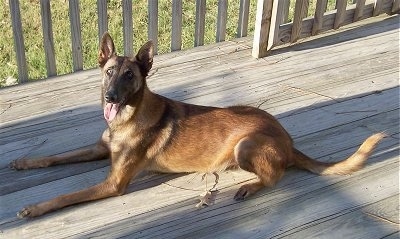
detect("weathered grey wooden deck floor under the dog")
[0,15,400,238]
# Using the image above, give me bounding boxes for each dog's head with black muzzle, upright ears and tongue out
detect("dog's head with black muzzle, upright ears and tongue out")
[99,32,153,122]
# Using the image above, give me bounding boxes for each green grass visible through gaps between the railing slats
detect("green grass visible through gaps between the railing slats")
[0,0,351,86]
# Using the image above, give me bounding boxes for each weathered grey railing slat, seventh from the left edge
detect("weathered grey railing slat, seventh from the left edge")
[171,0,182,51]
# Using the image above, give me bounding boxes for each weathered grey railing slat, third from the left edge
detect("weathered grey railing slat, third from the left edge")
[68,0,83,71]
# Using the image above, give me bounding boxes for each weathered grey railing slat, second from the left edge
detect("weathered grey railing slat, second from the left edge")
[40,0,57,77]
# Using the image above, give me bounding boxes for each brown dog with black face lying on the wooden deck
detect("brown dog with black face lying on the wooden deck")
[11,32,385,218]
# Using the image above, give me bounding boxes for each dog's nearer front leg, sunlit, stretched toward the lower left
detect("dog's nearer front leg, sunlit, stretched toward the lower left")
[17,152,145,218]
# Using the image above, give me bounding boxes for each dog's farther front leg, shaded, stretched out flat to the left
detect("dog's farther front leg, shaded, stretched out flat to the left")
[10,138,109,170]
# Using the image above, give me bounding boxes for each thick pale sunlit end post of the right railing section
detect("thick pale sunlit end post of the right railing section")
[252,0,279,58]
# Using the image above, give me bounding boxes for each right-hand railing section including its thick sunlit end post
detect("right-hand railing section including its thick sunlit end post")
[252,0,400,57]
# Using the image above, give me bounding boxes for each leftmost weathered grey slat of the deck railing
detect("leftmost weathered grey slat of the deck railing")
[8,0,28,83]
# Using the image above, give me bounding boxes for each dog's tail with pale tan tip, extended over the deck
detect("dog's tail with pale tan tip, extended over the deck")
[293,133,386,175]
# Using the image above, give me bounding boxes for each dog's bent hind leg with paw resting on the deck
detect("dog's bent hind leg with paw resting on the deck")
[234,134,287,200]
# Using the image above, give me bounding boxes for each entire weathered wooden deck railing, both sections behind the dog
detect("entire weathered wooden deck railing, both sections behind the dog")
[3,0,399,83]
